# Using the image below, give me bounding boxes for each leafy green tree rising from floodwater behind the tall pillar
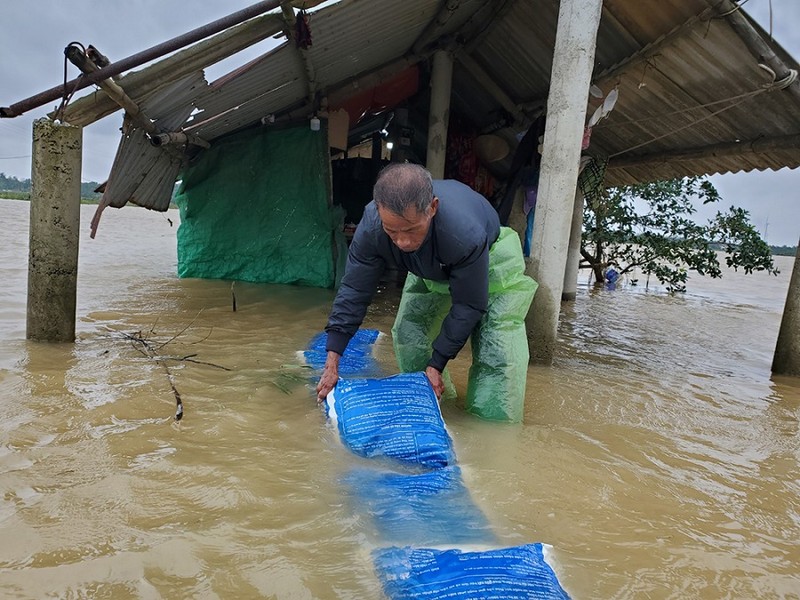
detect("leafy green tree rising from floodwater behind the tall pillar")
[581,177,778,292]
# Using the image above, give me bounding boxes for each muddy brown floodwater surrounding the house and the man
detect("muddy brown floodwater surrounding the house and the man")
[0,200,800,600]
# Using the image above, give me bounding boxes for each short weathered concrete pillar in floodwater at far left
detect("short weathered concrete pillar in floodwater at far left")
[26,119,83,342]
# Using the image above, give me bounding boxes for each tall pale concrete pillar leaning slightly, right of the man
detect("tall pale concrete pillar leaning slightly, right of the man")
[526,0,603,363]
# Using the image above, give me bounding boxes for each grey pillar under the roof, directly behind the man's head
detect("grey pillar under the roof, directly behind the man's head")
[425,50,453,179]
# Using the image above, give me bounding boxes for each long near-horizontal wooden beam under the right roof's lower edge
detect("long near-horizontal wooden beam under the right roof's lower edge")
[608,133,800,169]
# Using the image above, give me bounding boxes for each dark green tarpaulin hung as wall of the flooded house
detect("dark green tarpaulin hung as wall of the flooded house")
[176,126,346,287]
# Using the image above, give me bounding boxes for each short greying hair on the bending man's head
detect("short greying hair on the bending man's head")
[372,163,433,216]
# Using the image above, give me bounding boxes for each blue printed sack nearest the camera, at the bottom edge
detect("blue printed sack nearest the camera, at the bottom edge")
[373,544,569,600]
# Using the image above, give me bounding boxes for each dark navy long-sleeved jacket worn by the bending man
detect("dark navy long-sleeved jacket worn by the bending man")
[325,180,500,371]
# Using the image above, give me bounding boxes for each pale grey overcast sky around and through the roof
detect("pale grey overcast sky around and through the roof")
[0,0,800,246]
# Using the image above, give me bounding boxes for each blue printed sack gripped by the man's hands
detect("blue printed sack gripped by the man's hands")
[326,373,454,468]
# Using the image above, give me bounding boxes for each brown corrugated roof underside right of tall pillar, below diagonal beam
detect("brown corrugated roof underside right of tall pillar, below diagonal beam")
[593,3,800,185]
